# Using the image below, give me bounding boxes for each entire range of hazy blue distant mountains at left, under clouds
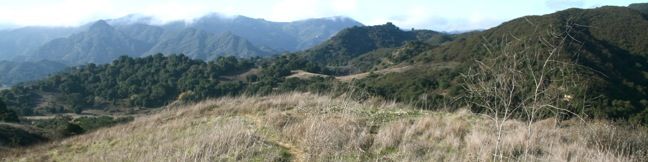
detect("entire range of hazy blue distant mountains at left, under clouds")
[0,14,362,65]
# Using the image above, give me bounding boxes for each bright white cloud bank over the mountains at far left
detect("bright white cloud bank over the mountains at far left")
[0,0,221,26]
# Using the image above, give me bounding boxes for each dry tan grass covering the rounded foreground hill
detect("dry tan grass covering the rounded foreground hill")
[2,94,648,161]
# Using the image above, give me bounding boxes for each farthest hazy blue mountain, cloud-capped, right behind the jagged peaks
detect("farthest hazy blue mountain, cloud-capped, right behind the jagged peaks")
[186,14,362,52]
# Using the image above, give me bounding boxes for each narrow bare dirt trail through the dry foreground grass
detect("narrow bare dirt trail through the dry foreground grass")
[245,114,306,162]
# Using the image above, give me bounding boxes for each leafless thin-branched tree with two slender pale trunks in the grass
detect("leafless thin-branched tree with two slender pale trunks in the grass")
[463,22,584,161]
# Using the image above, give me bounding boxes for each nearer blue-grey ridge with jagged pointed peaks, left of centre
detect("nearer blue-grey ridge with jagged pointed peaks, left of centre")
[28,21,277,65]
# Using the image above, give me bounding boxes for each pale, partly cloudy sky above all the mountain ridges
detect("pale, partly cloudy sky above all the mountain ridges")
[0,0,648,31]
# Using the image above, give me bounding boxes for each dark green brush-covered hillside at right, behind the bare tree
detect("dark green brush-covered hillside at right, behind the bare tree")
[357,7,648,123]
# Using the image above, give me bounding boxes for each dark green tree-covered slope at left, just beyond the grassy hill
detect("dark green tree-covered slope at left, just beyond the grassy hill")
[0,54,254,115]
